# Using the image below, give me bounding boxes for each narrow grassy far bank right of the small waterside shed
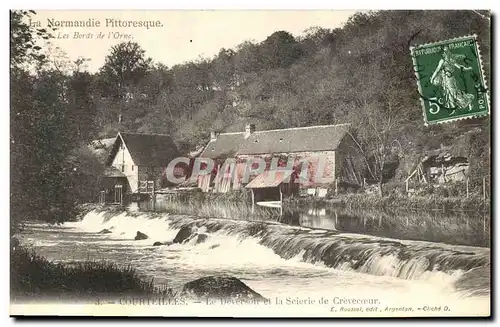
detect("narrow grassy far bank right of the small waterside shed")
[287,193,490,212]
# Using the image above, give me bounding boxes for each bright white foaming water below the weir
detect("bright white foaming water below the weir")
[49,212,489,310]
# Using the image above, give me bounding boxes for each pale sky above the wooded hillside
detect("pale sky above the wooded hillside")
[32,10,355,72]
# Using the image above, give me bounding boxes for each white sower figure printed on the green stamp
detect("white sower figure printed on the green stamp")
[430,46,474,110]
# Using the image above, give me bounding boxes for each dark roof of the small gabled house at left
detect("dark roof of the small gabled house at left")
[107,132,180,167]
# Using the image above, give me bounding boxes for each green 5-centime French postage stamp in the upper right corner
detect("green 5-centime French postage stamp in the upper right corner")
[410,35,490,126]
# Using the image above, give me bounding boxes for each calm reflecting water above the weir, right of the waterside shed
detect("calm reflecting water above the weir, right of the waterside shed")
[280,206,490,246]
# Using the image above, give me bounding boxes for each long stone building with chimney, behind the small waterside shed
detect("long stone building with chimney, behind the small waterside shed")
[197,124,363,196]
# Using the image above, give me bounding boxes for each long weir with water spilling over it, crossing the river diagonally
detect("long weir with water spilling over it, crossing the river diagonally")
[80,211,490,279]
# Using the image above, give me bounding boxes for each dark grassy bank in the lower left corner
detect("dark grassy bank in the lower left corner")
[10,246,174,301]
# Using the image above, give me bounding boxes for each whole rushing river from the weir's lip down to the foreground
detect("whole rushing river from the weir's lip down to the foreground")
[17,211,490,313]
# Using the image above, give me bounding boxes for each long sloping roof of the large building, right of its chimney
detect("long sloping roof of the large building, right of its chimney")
[237,124,350,154]
